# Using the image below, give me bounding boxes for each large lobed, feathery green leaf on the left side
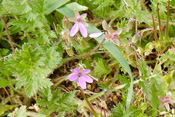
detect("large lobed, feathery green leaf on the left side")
[4,44,61,98]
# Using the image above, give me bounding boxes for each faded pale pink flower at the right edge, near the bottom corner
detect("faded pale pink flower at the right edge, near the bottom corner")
[159,92,175,112]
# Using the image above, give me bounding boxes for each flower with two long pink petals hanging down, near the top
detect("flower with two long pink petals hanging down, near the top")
[69,10,87,37]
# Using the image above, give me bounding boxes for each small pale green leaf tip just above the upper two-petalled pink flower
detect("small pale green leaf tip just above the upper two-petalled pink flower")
[66,2,88,11]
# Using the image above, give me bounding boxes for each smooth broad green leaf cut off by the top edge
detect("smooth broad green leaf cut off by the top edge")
[43,0,69,14]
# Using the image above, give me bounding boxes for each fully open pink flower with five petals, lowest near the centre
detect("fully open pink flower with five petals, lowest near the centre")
[69,68,93,89]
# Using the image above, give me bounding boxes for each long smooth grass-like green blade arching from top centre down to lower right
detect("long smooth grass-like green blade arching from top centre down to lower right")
[57,4,133,109]
